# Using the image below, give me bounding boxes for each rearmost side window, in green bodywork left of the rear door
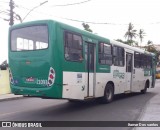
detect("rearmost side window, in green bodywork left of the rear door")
[64,32,83,61]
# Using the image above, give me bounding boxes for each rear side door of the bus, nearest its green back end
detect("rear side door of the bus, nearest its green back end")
[85,42,96,97]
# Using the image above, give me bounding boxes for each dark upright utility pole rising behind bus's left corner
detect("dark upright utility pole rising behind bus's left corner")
[9,0,14,26]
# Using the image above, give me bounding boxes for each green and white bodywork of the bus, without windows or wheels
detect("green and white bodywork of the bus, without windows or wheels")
[9,20,154,100]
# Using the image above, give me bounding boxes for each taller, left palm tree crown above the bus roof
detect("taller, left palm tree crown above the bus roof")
[124,23,137,45]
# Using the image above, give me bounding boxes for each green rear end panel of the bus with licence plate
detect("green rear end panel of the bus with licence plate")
[9,21,62,98]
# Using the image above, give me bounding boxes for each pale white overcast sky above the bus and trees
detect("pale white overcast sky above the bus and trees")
[0,0,160,63]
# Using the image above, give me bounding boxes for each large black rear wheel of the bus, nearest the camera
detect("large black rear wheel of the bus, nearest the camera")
[101,84,114,104]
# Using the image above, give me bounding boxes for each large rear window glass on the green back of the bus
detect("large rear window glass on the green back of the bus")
[10,25,48,51]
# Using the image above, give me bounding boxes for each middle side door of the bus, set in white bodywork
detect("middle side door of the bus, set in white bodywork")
[125,53,133,91]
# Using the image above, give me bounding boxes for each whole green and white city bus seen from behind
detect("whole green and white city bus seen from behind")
[9,20,155,103]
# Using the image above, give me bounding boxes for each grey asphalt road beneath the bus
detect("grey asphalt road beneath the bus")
[0,81,160,130]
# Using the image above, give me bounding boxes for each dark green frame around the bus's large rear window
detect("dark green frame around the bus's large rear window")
[9,23,50,53]
